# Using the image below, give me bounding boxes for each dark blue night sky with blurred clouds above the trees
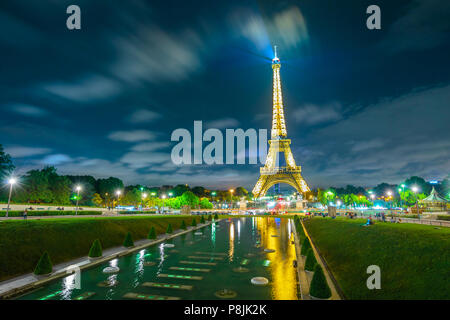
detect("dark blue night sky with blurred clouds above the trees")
[0,0,450,189]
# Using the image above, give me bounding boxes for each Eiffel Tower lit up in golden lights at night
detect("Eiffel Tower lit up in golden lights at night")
[253,46,310,198]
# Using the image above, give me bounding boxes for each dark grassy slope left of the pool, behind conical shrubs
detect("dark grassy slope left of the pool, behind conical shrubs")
[0,216,193,281]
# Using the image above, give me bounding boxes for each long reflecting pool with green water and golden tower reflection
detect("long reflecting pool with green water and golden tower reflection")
[18,217,298,300]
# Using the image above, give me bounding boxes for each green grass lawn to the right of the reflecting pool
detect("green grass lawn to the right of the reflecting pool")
[305,218,450,299]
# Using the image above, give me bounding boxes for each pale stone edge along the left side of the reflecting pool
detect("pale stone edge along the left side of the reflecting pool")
[0,219,218,300]
